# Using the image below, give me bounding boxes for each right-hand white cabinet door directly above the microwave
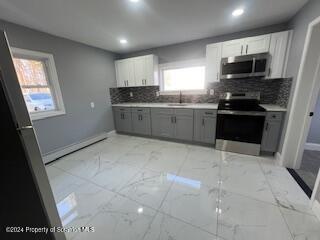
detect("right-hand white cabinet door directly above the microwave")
[243,34,271,55]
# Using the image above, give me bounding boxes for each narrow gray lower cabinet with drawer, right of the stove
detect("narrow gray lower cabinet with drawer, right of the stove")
[261,112,283,153]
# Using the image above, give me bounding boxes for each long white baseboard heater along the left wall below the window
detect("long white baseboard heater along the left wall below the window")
[42,131,110,163]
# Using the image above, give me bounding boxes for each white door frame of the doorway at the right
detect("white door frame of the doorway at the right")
[280,16,320,204]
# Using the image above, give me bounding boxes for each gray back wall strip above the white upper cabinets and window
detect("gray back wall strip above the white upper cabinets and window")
[120,23,288,63]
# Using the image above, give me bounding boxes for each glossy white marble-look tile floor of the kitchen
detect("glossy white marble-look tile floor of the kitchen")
[46,134,320,240]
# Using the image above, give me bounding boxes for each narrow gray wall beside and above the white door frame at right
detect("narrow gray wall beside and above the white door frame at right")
[280,0,320,152]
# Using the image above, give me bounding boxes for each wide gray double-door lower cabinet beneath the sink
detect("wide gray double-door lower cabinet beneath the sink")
[151,108,193,141]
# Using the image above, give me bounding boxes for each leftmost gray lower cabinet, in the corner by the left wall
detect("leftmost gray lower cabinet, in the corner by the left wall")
[113,107,132,133]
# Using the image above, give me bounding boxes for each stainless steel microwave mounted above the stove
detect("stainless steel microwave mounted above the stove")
[220,53,271,79]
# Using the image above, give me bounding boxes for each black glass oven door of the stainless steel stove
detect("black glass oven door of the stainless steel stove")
[216,111,265,145]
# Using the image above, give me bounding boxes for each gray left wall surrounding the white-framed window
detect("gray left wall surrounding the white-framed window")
[0,20,116,154]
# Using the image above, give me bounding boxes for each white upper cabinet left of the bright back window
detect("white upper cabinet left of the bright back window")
[115,55,159,87]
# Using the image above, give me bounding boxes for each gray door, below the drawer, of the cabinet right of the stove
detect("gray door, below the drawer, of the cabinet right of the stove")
[261,121,281,152]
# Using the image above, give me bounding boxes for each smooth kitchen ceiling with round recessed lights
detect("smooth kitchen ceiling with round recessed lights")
[0,0,308,53]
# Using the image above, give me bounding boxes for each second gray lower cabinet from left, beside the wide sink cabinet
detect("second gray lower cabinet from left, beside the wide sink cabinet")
[132,108,151,135]
